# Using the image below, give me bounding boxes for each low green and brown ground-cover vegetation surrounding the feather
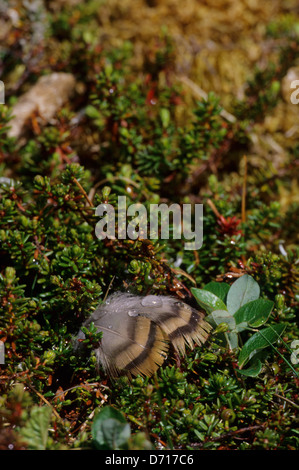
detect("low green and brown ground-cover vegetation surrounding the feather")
[0,0,299,450]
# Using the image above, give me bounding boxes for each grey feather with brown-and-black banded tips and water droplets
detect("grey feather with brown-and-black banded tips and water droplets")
[78,293,211,377]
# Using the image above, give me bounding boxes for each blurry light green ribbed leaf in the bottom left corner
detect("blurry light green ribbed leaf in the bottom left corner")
[20,406,52,450]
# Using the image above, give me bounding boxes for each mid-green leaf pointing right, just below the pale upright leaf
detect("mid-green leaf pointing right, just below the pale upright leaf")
[234,299,274,331]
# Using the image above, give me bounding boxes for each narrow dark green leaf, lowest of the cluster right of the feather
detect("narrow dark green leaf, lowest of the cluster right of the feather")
[238,324,285,368]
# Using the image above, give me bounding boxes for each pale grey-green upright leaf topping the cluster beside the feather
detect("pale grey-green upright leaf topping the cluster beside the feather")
[226,274,260,314]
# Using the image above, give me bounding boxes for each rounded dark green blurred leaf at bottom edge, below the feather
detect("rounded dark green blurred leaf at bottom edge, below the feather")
[91,406,131,450]
